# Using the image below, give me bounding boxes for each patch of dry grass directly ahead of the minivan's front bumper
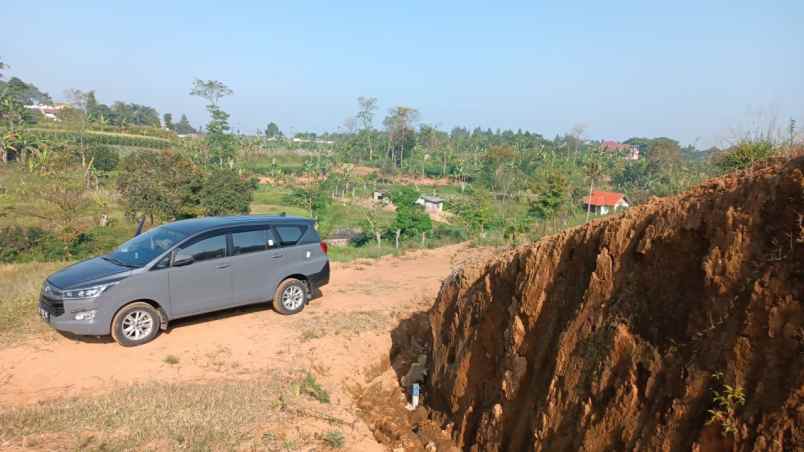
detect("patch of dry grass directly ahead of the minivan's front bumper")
[0,262,67,345]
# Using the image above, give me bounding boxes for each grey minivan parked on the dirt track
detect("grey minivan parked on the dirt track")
[39,216,330,346]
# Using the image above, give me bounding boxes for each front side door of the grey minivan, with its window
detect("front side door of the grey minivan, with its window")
[169,232,233,317]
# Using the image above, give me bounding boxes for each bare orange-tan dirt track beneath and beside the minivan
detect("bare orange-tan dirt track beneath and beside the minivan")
[0,245,488,450]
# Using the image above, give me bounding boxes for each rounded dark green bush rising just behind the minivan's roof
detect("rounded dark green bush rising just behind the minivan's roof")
[199,168,257,216]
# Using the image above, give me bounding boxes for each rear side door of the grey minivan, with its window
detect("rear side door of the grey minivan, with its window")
[232,226,284,305]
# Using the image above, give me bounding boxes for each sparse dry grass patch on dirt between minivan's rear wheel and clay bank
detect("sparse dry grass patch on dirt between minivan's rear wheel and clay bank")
[298,311,392,342]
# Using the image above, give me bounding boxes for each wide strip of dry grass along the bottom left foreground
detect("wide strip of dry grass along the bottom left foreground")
[0,373,339,451]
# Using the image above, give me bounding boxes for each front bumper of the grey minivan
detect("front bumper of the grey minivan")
[39,294,111,336]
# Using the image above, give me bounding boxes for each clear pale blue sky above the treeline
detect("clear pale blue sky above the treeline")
[0,0,804,146]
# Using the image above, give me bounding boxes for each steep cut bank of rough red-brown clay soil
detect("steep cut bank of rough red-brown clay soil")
[418,156,804,451]
